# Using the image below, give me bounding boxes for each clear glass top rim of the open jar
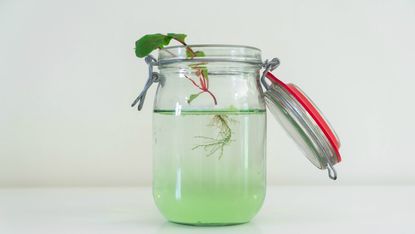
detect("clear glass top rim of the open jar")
[158,44,262,65]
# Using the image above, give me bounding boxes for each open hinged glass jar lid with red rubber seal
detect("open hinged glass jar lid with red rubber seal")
[265,71,341,180]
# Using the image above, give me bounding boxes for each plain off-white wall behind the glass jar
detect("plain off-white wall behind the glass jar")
[0,0,415,186]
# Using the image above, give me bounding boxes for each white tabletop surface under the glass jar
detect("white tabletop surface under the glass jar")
[0,186,415,234]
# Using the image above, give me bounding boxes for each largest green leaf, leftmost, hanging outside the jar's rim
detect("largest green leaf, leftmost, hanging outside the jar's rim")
[135,33,172,58]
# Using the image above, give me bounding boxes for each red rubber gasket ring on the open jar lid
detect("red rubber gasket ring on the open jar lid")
[265,72,342,162]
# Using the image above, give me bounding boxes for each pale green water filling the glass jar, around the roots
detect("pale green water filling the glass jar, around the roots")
[153,110,266,225]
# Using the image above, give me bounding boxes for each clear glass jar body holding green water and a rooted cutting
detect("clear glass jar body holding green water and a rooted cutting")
[153,45,266,225]
